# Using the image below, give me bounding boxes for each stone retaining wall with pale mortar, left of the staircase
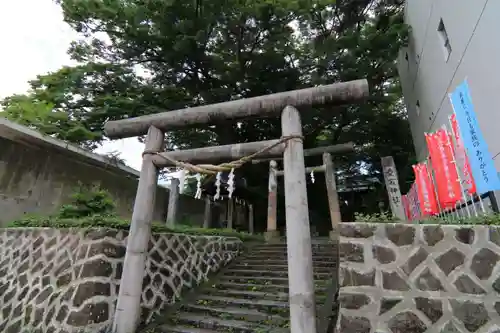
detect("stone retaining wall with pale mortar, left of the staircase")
[0,229,242,333]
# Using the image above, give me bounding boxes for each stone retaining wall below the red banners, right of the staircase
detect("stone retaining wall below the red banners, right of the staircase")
[338,223,500,333]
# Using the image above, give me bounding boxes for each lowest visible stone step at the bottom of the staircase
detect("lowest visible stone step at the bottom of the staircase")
[161,312,289,333]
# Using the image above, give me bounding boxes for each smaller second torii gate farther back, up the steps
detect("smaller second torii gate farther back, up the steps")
[264,142,355,242]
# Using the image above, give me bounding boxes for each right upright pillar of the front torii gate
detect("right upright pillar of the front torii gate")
[281,106,316,333]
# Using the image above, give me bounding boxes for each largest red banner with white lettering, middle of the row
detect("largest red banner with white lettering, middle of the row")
[425,129,462,209]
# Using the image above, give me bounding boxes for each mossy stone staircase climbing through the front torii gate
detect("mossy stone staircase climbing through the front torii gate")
[152,240,335,333]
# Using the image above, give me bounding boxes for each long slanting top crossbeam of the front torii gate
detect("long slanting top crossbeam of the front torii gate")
[104,79,368,139]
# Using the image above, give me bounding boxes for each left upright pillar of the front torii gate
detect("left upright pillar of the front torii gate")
[113,126,164,333]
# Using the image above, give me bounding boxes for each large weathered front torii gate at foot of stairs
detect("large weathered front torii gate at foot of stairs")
[104,80,368,333]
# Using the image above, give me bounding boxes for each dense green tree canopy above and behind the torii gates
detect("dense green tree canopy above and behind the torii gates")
[3,0,413,220]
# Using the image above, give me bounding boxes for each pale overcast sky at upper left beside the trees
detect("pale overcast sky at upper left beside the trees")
[0,0,144,169]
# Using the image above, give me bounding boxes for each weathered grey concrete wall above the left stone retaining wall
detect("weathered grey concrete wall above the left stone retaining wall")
[0,118,205,226]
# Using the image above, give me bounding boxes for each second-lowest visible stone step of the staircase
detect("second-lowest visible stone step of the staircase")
[181,305,289,327]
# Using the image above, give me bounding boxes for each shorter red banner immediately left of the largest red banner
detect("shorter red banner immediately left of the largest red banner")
[413,163,439,216]
